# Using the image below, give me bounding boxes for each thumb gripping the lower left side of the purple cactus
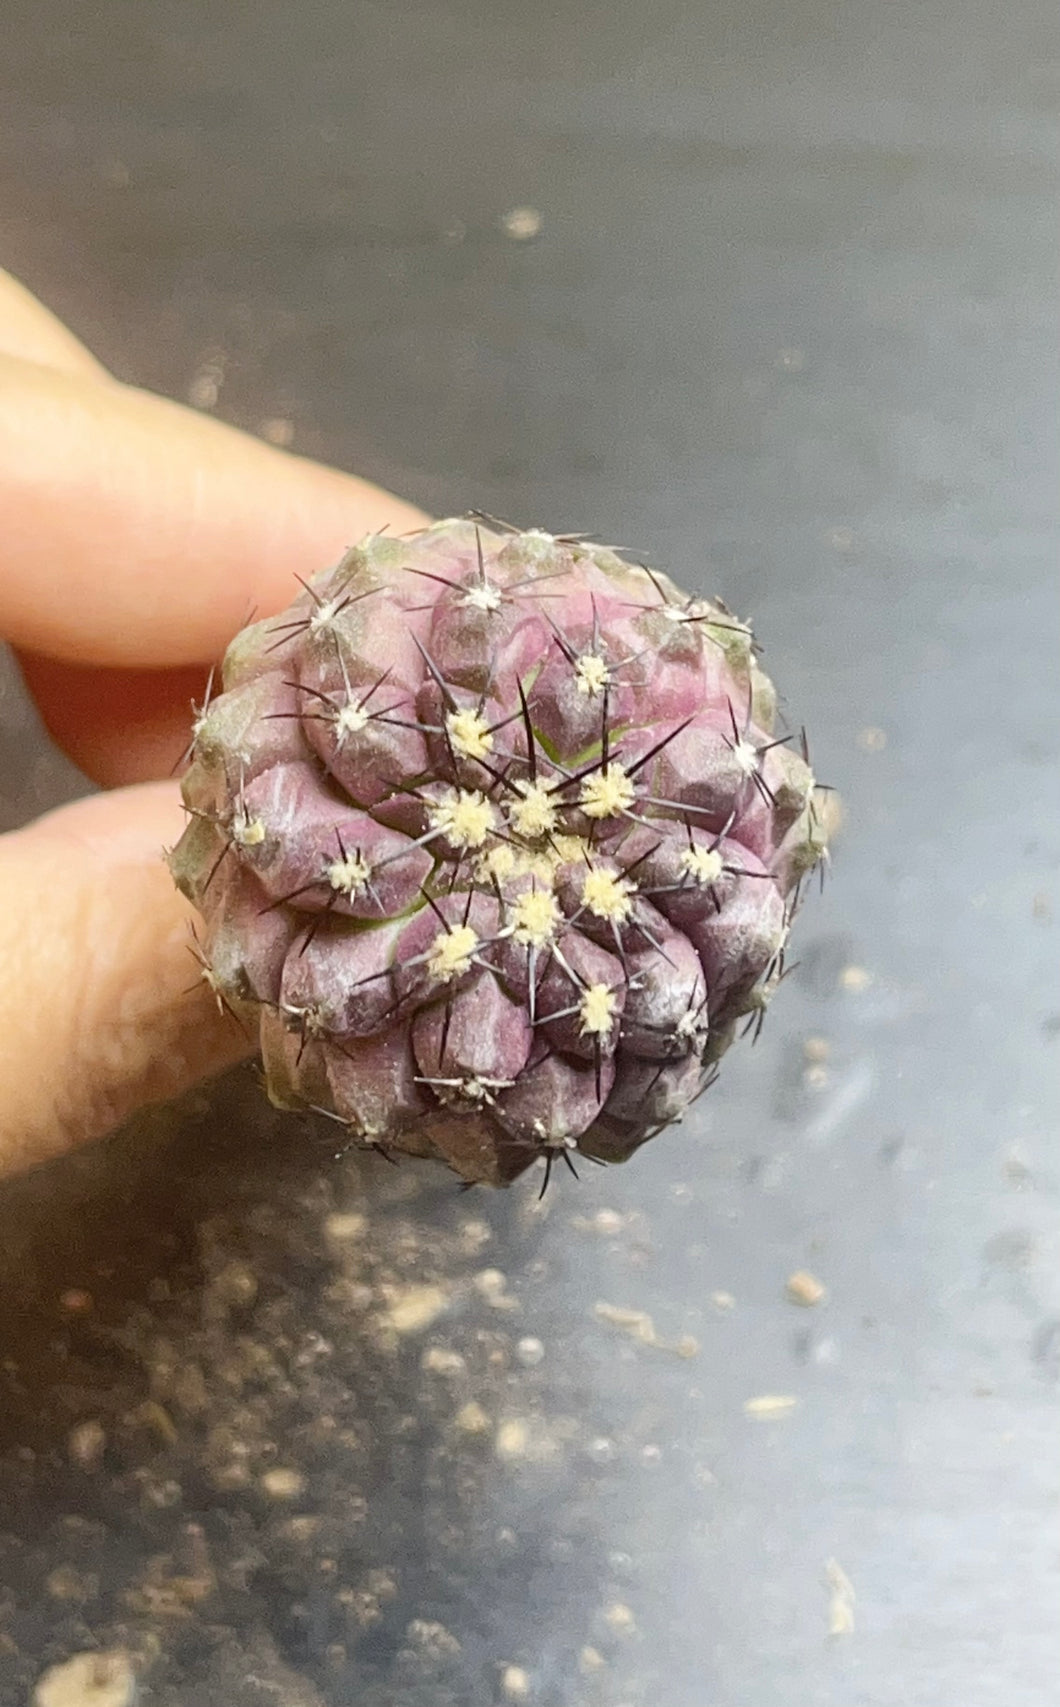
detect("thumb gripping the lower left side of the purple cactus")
[0,784,251,1174]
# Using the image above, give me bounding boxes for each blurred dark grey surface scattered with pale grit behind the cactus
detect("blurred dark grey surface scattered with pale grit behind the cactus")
[0,0,1060,1707]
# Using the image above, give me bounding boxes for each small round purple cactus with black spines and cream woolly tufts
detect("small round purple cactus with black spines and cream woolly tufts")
[171,519,826,1185]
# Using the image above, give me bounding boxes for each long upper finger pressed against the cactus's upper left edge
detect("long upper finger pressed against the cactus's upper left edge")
[0,357,427,667]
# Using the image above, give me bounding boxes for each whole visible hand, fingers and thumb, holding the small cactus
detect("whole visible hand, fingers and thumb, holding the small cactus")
[0,271,427,1174]
